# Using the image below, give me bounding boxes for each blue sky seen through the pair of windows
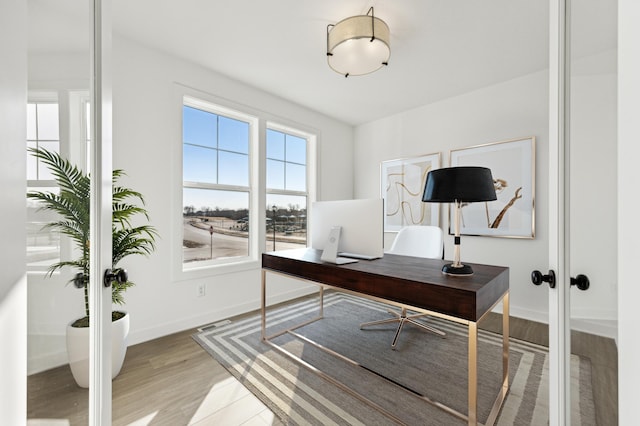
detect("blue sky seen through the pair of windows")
[183,106,307,210]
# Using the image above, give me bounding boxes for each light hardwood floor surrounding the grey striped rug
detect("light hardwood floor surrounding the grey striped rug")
[28,308,618,426]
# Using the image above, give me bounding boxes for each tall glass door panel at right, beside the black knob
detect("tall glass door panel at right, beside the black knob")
[567,0,618,424]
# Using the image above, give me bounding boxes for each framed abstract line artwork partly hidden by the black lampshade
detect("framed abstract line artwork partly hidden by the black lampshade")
[380,153,440,232]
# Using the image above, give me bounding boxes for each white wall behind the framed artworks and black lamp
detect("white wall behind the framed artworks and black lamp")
[355,55,617,335]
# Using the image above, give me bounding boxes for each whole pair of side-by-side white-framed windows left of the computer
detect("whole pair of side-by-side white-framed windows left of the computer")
[180,90,316,272]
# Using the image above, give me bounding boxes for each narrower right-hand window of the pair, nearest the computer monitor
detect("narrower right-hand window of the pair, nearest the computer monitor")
[266,125,309,251]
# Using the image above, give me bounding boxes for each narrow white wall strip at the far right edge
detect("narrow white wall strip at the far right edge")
[612,0,640,426]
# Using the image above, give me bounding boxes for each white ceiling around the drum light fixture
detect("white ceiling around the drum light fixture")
[29,0,617,125]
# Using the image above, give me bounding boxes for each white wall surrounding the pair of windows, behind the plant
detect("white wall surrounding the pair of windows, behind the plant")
[29,36,353,372]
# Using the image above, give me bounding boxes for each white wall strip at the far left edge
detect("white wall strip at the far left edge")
[0,0,27,425]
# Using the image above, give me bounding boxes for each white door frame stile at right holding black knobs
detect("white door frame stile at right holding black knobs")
[549,0,571,426]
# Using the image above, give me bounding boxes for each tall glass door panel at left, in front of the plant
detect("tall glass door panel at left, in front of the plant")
[24,1,92,424]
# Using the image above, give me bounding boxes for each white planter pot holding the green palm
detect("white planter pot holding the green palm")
[67,313,129,388]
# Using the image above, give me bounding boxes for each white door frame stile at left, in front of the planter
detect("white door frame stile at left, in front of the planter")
[89,0,112,426]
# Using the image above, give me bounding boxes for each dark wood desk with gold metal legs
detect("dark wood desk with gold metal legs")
[261,249,509,425]
